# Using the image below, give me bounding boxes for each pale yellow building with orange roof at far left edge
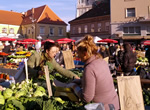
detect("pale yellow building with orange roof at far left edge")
[0,10,23,38]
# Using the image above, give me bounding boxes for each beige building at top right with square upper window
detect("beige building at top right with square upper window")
[111,0,150,43]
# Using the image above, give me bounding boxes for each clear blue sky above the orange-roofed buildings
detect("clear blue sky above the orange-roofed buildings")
[0,0,77,30]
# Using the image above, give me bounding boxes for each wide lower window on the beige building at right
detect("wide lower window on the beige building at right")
[123,27,141,34]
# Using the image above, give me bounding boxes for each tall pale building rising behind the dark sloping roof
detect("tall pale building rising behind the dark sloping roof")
[76,0,96,17]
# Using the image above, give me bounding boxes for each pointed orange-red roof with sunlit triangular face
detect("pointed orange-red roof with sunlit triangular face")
[22,5,67,25]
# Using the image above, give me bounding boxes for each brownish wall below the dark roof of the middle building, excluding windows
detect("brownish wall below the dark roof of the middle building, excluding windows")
[70,16,111,38]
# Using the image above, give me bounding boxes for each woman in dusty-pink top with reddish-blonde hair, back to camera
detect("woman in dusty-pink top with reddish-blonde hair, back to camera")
[67,35,119,110]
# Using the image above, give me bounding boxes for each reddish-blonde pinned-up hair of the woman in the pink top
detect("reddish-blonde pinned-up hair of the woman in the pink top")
[77,35,102,58]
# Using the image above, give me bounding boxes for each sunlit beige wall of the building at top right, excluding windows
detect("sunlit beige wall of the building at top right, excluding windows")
[111,0,150,37]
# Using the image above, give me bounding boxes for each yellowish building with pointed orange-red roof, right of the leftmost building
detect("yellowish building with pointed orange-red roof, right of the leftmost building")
[21,5,67,40]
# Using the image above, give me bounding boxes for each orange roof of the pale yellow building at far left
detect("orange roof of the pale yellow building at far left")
[0,10,22,25]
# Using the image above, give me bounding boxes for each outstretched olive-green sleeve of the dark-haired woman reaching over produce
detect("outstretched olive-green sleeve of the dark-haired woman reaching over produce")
[45,58,77,79]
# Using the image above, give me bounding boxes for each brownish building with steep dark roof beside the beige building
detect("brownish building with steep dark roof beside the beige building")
[69,3,111,40]
